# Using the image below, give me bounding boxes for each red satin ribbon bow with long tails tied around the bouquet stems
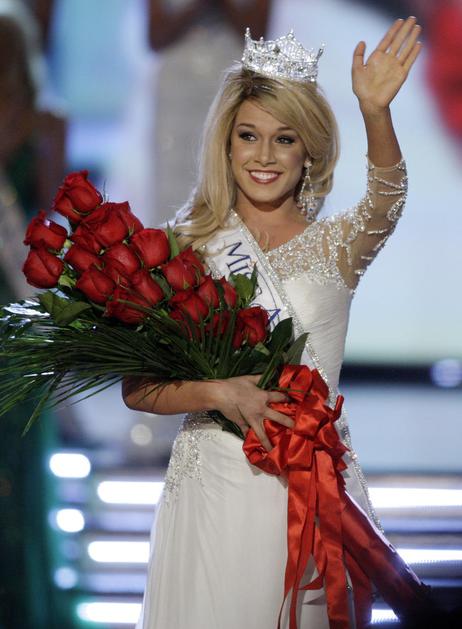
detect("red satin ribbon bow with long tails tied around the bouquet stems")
[243,365,428,629]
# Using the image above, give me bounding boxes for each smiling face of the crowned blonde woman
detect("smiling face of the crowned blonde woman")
[230,100,308,210]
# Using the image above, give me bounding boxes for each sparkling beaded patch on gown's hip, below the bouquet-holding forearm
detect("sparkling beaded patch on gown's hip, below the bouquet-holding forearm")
[162,412,217,504]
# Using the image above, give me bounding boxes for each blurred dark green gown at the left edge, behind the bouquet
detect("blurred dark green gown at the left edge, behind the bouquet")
[0,168,73,629]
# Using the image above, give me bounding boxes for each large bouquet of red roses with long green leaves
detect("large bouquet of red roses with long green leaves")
[0,171,305,436]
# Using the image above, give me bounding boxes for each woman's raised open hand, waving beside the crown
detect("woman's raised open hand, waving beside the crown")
[352,16,422,114]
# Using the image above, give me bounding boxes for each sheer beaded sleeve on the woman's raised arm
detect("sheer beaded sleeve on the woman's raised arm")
[324,160,407,289]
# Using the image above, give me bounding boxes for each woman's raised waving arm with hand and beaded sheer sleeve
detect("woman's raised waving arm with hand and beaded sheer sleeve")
[325,17,421,289]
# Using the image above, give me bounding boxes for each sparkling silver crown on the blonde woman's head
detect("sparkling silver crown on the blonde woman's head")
[242,28,324,83]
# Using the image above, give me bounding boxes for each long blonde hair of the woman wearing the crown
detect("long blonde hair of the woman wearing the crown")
[174,65,339,249]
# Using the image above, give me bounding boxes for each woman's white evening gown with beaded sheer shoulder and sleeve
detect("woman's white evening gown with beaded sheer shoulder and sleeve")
[137,162,406,629]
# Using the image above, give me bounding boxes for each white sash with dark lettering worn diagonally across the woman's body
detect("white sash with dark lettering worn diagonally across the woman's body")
[206,211,383,532]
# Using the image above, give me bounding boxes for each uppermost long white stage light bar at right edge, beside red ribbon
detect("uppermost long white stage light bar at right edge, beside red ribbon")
[369,487,462,509]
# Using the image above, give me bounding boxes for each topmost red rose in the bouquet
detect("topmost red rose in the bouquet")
[53,170,103,223]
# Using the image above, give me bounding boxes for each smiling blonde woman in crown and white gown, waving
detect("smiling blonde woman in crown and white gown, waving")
[123,17,426,629]
